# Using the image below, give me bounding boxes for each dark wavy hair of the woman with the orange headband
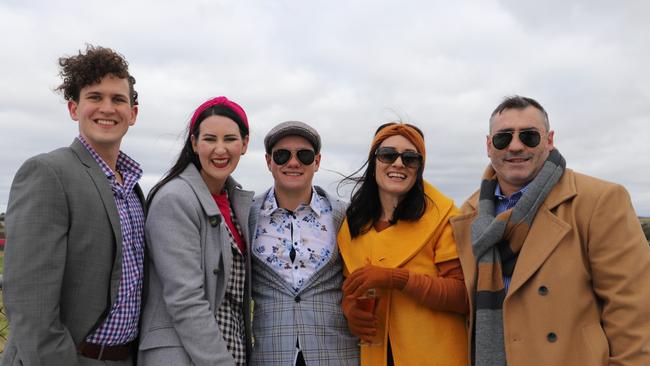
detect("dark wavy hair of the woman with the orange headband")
[338,122,431,238]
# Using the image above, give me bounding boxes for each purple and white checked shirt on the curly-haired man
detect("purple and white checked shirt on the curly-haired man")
[78,135,144,346]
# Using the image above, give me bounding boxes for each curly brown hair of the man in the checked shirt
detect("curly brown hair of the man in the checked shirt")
[56,45,138,105]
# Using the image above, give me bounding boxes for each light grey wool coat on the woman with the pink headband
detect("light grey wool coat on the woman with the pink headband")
[138,164,253,366]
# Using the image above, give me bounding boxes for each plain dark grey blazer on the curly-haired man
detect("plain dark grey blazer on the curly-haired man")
[0,139,142,366]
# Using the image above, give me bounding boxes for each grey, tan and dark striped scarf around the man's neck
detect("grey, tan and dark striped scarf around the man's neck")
[472,150,566,366]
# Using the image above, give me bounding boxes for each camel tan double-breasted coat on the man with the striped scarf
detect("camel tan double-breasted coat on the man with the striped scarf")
[451,169,650,366]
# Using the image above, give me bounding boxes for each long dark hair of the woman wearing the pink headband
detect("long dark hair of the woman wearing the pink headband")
[146,104,249,208]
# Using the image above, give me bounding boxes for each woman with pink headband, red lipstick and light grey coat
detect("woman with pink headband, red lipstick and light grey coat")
[139,97,253,366]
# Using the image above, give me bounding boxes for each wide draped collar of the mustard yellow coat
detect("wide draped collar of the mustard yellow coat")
[338,181,454,273]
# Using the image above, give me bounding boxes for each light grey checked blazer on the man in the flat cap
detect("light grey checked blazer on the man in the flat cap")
[249,186,359,366]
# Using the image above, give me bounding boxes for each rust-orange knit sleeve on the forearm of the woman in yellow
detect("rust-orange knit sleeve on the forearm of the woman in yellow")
[394,259,469,314]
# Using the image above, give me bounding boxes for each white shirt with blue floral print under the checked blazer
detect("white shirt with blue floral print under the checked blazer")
[253,188,336,292]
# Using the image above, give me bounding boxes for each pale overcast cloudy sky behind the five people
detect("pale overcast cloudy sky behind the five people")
[0,0,650,216]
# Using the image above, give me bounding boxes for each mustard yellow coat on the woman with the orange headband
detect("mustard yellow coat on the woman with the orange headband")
[338,182,468,366]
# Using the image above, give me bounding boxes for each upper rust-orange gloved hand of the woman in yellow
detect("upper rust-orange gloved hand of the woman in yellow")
[343,264,408,298]
